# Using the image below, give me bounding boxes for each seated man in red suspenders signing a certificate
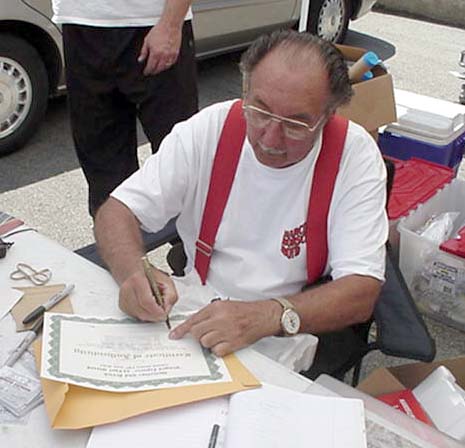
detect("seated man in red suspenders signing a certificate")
[95,31,388,368]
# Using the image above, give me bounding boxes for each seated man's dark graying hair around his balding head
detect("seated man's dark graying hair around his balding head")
[239,30,353,112]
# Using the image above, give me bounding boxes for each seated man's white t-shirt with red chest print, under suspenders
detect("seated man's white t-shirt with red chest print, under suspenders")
[112,101,388,300]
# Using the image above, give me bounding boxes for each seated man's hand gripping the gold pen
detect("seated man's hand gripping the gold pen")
[119,270,178,322]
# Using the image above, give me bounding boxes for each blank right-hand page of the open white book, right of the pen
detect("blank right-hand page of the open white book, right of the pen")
[225,385,366,448]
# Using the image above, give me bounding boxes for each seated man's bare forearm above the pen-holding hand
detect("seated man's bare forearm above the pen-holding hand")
[94,198,144,284]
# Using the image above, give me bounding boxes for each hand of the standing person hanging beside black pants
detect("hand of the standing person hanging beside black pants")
[137,22,182,75]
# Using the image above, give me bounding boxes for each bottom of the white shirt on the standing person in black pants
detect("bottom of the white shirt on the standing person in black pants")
[52,0,192,27]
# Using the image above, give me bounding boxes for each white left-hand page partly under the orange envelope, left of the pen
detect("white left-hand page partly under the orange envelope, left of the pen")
[87,397,228,448]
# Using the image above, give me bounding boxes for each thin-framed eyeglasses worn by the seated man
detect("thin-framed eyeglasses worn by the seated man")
[242,104,324,140]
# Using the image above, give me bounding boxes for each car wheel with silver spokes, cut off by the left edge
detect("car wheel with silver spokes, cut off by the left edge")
[0,34,49,155]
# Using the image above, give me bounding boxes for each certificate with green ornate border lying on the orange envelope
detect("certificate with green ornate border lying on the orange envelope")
[41,313,231,392]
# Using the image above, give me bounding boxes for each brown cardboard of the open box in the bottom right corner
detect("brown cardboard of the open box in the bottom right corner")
[357,356,465,397]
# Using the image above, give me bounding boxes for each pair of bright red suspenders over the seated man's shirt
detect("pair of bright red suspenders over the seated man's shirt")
[194,101,348,284]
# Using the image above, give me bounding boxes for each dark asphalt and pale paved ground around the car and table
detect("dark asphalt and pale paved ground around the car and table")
[0,9,465,382]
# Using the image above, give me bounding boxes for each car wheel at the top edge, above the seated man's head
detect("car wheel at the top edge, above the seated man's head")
[307,0,351,43]
